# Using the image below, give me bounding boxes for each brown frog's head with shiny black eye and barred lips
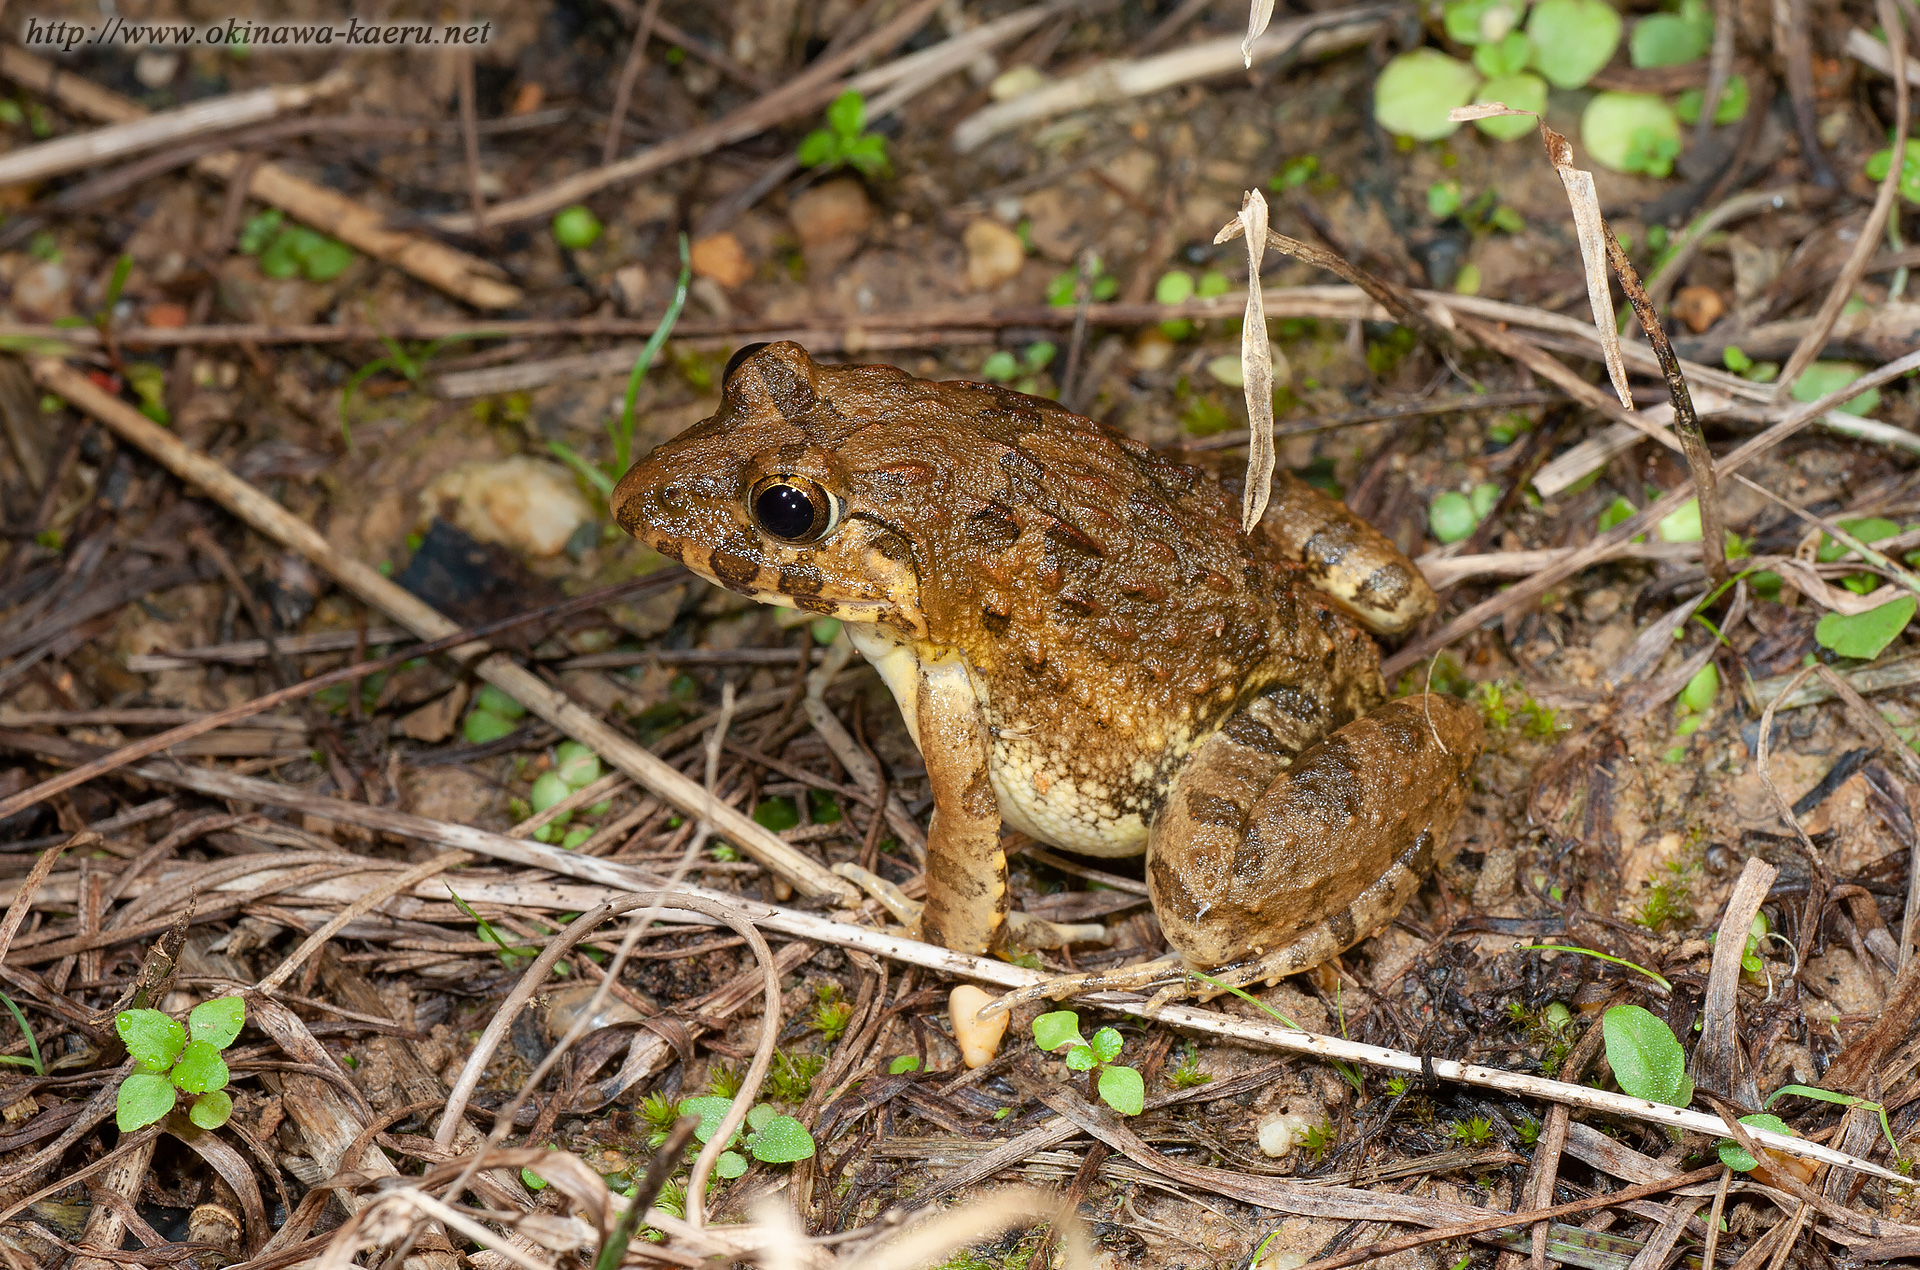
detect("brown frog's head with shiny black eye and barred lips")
[612,342,925,636]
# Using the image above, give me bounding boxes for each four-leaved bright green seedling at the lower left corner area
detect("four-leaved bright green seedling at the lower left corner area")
[113,997,246,1134]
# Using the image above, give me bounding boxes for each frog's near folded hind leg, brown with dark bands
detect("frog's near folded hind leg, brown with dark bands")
[1146,696,1482,974]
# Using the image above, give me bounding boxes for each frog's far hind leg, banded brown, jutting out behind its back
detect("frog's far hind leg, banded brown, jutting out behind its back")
[1260,471,1440,634]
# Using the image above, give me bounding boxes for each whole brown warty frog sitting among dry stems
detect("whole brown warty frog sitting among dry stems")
[612,342,1482,1006]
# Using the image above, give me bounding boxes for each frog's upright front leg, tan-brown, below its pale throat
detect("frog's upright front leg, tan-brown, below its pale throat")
[914,657,1008,953]
